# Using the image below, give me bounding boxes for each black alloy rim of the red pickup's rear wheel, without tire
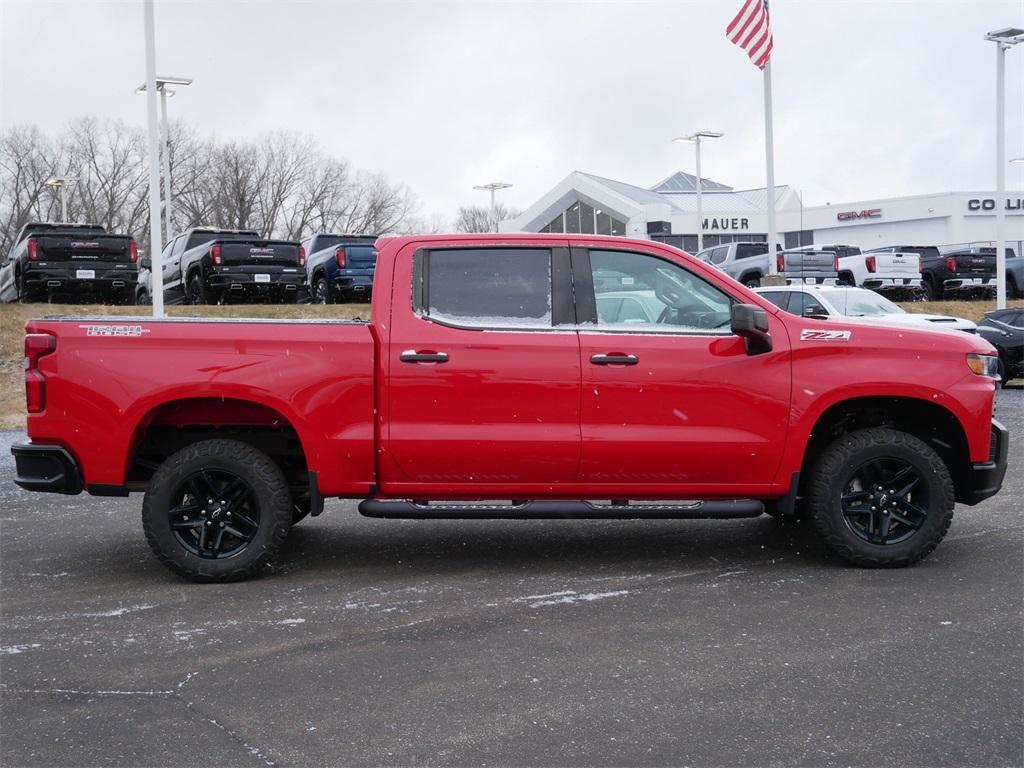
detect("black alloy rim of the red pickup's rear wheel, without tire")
[169,469,260,560]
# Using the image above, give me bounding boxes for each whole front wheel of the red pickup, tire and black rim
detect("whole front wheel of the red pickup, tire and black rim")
[807,428,953,568]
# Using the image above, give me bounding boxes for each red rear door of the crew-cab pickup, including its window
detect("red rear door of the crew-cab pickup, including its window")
[380,242,580,498]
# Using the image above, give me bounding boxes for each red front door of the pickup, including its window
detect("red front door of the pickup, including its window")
[572,246,791,498]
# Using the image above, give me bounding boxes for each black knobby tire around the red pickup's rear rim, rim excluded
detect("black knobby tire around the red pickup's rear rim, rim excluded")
[142,439,293,583]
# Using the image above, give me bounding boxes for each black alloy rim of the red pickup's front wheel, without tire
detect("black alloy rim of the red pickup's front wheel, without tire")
[840,458,930,545]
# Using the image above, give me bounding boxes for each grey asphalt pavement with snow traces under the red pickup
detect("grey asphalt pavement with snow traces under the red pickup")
[0,388,1024,767]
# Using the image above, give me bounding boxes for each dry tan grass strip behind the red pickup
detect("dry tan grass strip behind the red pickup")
[0,299,1024,436]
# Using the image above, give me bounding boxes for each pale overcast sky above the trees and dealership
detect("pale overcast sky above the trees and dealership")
[0,0,1024,222]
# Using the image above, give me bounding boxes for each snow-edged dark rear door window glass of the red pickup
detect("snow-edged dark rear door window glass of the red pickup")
[427,248,551,327]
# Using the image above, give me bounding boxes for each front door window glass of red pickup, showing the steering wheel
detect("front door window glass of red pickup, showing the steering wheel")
[590,251,732,331]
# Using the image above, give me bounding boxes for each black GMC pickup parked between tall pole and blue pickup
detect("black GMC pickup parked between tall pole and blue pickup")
[163,227,309,304]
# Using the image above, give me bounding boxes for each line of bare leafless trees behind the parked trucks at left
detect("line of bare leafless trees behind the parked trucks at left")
[0,118,423,250]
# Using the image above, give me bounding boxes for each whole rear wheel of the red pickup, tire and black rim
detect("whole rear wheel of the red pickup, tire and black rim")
[142,439,293,582]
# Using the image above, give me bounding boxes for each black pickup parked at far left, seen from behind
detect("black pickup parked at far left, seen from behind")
[0,221,138,304]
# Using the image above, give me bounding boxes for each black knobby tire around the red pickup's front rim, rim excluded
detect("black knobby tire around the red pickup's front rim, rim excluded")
[805,427,954,568]
